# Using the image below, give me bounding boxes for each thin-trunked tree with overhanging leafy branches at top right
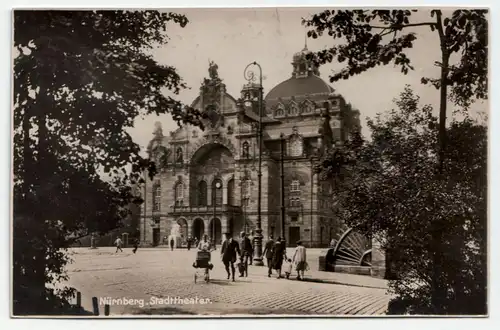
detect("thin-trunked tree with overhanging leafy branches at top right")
[303,9,488,170]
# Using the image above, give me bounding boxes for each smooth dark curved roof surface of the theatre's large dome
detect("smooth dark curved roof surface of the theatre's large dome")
[265,75,334,101]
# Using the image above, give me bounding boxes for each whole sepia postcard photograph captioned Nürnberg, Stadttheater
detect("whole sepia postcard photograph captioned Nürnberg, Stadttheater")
[9,7,490,319]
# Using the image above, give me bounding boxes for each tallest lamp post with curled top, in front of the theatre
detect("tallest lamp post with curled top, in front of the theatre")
[243,62,264,266]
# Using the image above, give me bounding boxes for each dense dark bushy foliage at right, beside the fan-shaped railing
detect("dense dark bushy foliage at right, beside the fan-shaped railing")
[319,87,487,315]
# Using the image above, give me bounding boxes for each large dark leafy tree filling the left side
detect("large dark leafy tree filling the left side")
[13,10,199,314]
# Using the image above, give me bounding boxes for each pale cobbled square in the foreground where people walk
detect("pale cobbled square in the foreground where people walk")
[63,248,390,315]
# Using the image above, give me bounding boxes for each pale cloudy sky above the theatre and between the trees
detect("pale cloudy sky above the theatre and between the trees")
[130,8,487,152]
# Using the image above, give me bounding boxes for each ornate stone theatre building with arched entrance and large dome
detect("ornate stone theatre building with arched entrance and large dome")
[140,48,360,247]
